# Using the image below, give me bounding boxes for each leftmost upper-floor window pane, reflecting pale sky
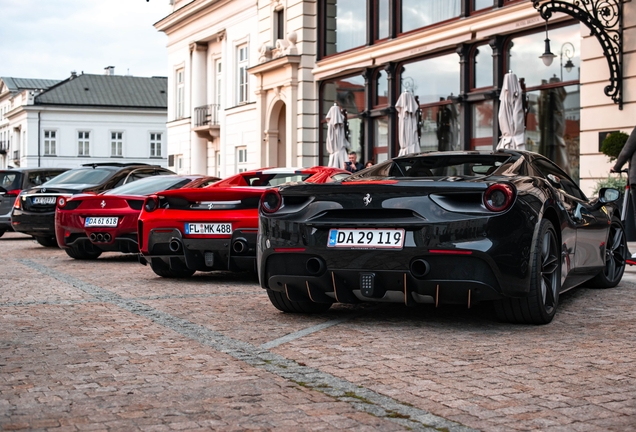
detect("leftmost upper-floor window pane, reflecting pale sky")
[325,0,367,55]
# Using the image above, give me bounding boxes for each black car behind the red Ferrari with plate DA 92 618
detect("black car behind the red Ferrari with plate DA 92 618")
[11,162,174,246]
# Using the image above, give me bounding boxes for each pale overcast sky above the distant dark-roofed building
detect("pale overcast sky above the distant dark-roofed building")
[0,0,170,80]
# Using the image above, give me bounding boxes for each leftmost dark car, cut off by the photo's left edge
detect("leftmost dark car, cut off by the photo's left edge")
[0,168,70,237]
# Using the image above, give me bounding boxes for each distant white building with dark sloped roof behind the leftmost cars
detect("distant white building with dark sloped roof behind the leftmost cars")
[0,67,167,168]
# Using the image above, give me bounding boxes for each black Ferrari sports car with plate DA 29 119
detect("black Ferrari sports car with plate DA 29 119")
[257,150,627,324]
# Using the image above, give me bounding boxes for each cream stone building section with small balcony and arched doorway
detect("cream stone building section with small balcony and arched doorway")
[155,0,317,176]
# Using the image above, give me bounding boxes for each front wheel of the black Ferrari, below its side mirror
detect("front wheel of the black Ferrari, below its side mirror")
[585,219,627,288]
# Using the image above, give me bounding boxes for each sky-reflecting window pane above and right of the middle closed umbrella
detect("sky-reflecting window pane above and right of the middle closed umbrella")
[400,53,460,104]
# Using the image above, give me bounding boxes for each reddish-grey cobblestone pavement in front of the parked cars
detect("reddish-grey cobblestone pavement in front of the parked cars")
[0,233,636,431]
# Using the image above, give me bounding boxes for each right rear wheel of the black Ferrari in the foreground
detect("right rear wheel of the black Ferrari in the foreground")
[495,219,561,324]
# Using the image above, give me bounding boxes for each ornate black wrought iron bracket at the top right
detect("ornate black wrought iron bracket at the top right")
[532,0,623,110]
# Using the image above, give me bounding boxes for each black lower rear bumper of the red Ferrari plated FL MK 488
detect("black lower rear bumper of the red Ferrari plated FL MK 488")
[142,228,257,271]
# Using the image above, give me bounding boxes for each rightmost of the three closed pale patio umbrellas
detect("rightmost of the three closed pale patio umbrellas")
[497,72,526,150]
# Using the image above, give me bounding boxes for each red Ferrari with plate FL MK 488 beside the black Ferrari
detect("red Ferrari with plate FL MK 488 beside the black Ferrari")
[137,166,351,278]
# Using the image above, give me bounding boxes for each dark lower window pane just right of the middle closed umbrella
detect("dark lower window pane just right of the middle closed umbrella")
[420,102,461,151]
